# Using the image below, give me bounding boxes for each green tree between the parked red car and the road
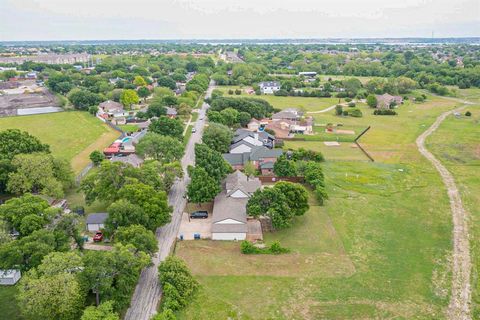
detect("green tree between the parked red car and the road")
[115,224,158,255]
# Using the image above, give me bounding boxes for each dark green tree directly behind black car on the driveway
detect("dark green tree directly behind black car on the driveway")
[187,166,221,204]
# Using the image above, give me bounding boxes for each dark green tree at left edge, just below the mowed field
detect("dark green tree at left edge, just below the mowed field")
[0,129,50,160]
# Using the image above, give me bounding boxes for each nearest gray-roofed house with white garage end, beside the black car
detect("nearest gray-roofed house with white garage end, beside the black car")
[212,170,262,240]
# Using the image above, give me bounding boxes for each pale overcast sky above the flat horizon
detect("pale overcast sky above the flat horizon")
[0,0,480,41]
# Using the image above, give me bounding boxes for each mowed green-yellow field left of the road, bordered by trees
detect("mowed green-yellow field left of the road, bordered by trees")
[0,111,119,173]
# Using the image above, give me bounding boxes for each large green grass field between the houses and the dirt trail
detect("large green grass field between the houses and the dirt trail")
[176,91,464,319]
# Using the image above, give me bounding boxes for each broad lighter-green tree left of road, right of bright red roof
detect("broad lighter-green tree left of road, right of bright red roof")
[136,133,184,163]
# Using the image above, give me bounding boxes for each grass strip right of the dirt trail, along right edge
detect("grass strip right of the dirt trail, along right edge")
[427,99,480,319]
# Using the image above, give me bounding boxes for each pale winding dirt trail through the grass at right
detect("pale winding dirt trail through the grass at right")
[416,98,473,320]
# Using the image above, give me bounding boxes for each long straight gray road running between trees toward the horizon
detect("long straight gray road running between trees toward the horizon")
[125,83,214,320]
